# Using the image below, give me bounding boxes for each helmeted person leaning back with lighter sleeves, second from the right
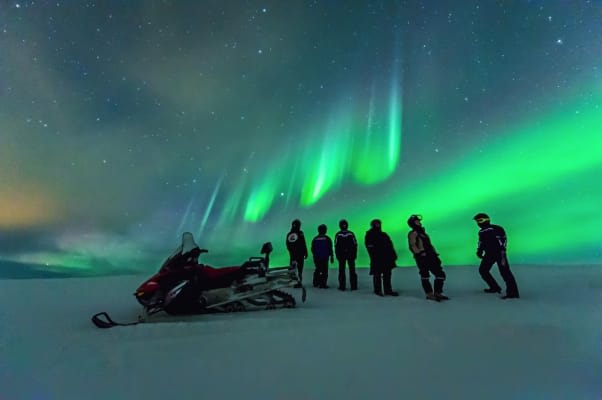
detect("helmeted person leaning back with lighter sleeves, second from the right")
[408,214,449,301]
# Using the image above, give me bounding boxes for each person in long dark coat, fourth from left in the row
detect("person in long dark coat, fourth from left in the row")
[364,219,399,296]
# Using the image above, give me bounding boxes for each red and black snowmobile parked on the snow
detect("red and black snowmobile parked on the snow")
[92,242,307,328]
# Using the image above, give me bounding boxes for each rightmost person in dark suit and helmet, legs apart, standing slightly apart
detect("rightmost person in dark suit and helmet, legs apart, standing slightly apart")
[473,213,520,299]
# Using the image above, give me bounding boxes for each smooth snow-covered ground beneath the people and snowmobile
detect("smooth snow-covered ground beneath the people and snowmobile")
[0,266,602,400]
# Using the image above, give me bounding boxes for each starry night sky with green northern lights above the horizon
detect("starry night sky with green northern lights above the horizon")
[0,0,602,277]
